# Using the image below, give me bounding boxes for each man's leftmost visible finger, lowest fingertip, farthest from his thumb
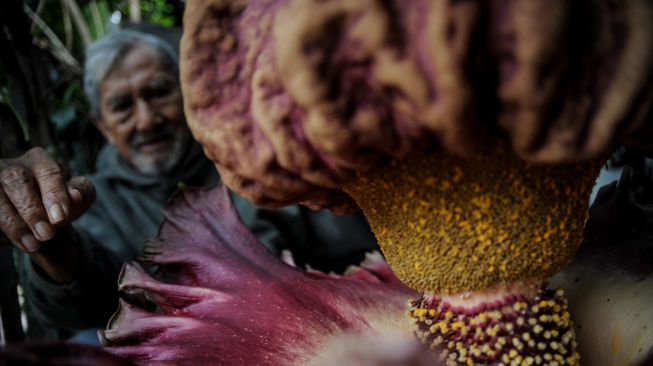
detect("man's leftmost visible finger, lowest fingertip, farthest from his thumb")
[0,189,41,252]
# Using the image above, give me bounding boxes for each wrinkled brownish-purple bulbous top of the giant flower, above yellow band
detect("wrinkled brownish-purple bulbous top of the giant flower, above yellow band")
[182,0,653,210]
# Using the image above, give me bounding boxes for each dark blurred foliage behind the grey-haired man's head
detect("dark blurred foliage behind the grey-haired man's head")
[0,0,185,174]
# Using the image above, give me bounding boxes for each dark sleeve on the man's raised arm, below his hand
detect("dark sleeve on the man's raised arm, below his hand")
[19,207,122,330]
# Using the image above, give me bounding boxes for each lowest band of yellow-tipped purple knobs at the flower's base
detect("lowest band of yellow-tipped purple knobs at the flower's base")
[408,289,580,366]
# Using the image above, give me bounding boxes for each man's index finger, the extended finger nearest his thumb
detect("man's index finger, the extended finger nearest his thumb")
[32,155,70,225]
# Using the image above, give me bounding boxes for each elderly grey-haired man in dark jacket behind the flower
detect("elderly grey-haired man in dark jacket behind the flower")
[0,31,376,330]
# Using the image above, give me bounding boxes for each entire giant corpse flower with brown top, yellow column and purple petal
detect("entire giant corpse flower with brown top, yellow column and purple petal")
[3,0,653,365]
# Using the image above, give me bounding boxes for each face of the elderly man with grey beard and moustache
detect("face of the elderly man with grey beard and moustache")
[98,45,190,174]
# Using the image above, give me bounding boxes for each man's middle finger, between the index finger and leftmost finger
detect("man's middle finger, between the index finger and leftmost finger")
[0,165,54,241]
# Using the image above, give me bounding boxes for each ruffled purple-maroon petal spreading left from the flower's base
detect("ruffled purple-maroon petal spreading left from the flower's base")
[100,187,440,366]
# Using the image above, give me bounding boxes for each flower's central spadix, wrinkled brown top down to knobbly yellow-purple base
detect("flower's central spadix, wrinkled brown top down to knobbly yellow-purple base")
[181,0,653,364]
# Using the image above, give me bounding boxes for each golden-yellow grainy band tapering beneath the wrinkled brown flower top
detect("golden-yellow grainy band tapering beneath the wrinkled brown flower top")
[346,143,601,294]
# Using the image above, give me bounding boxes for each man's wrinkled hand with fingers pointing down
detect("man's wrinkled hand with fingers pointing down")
[0,147,95,253]
